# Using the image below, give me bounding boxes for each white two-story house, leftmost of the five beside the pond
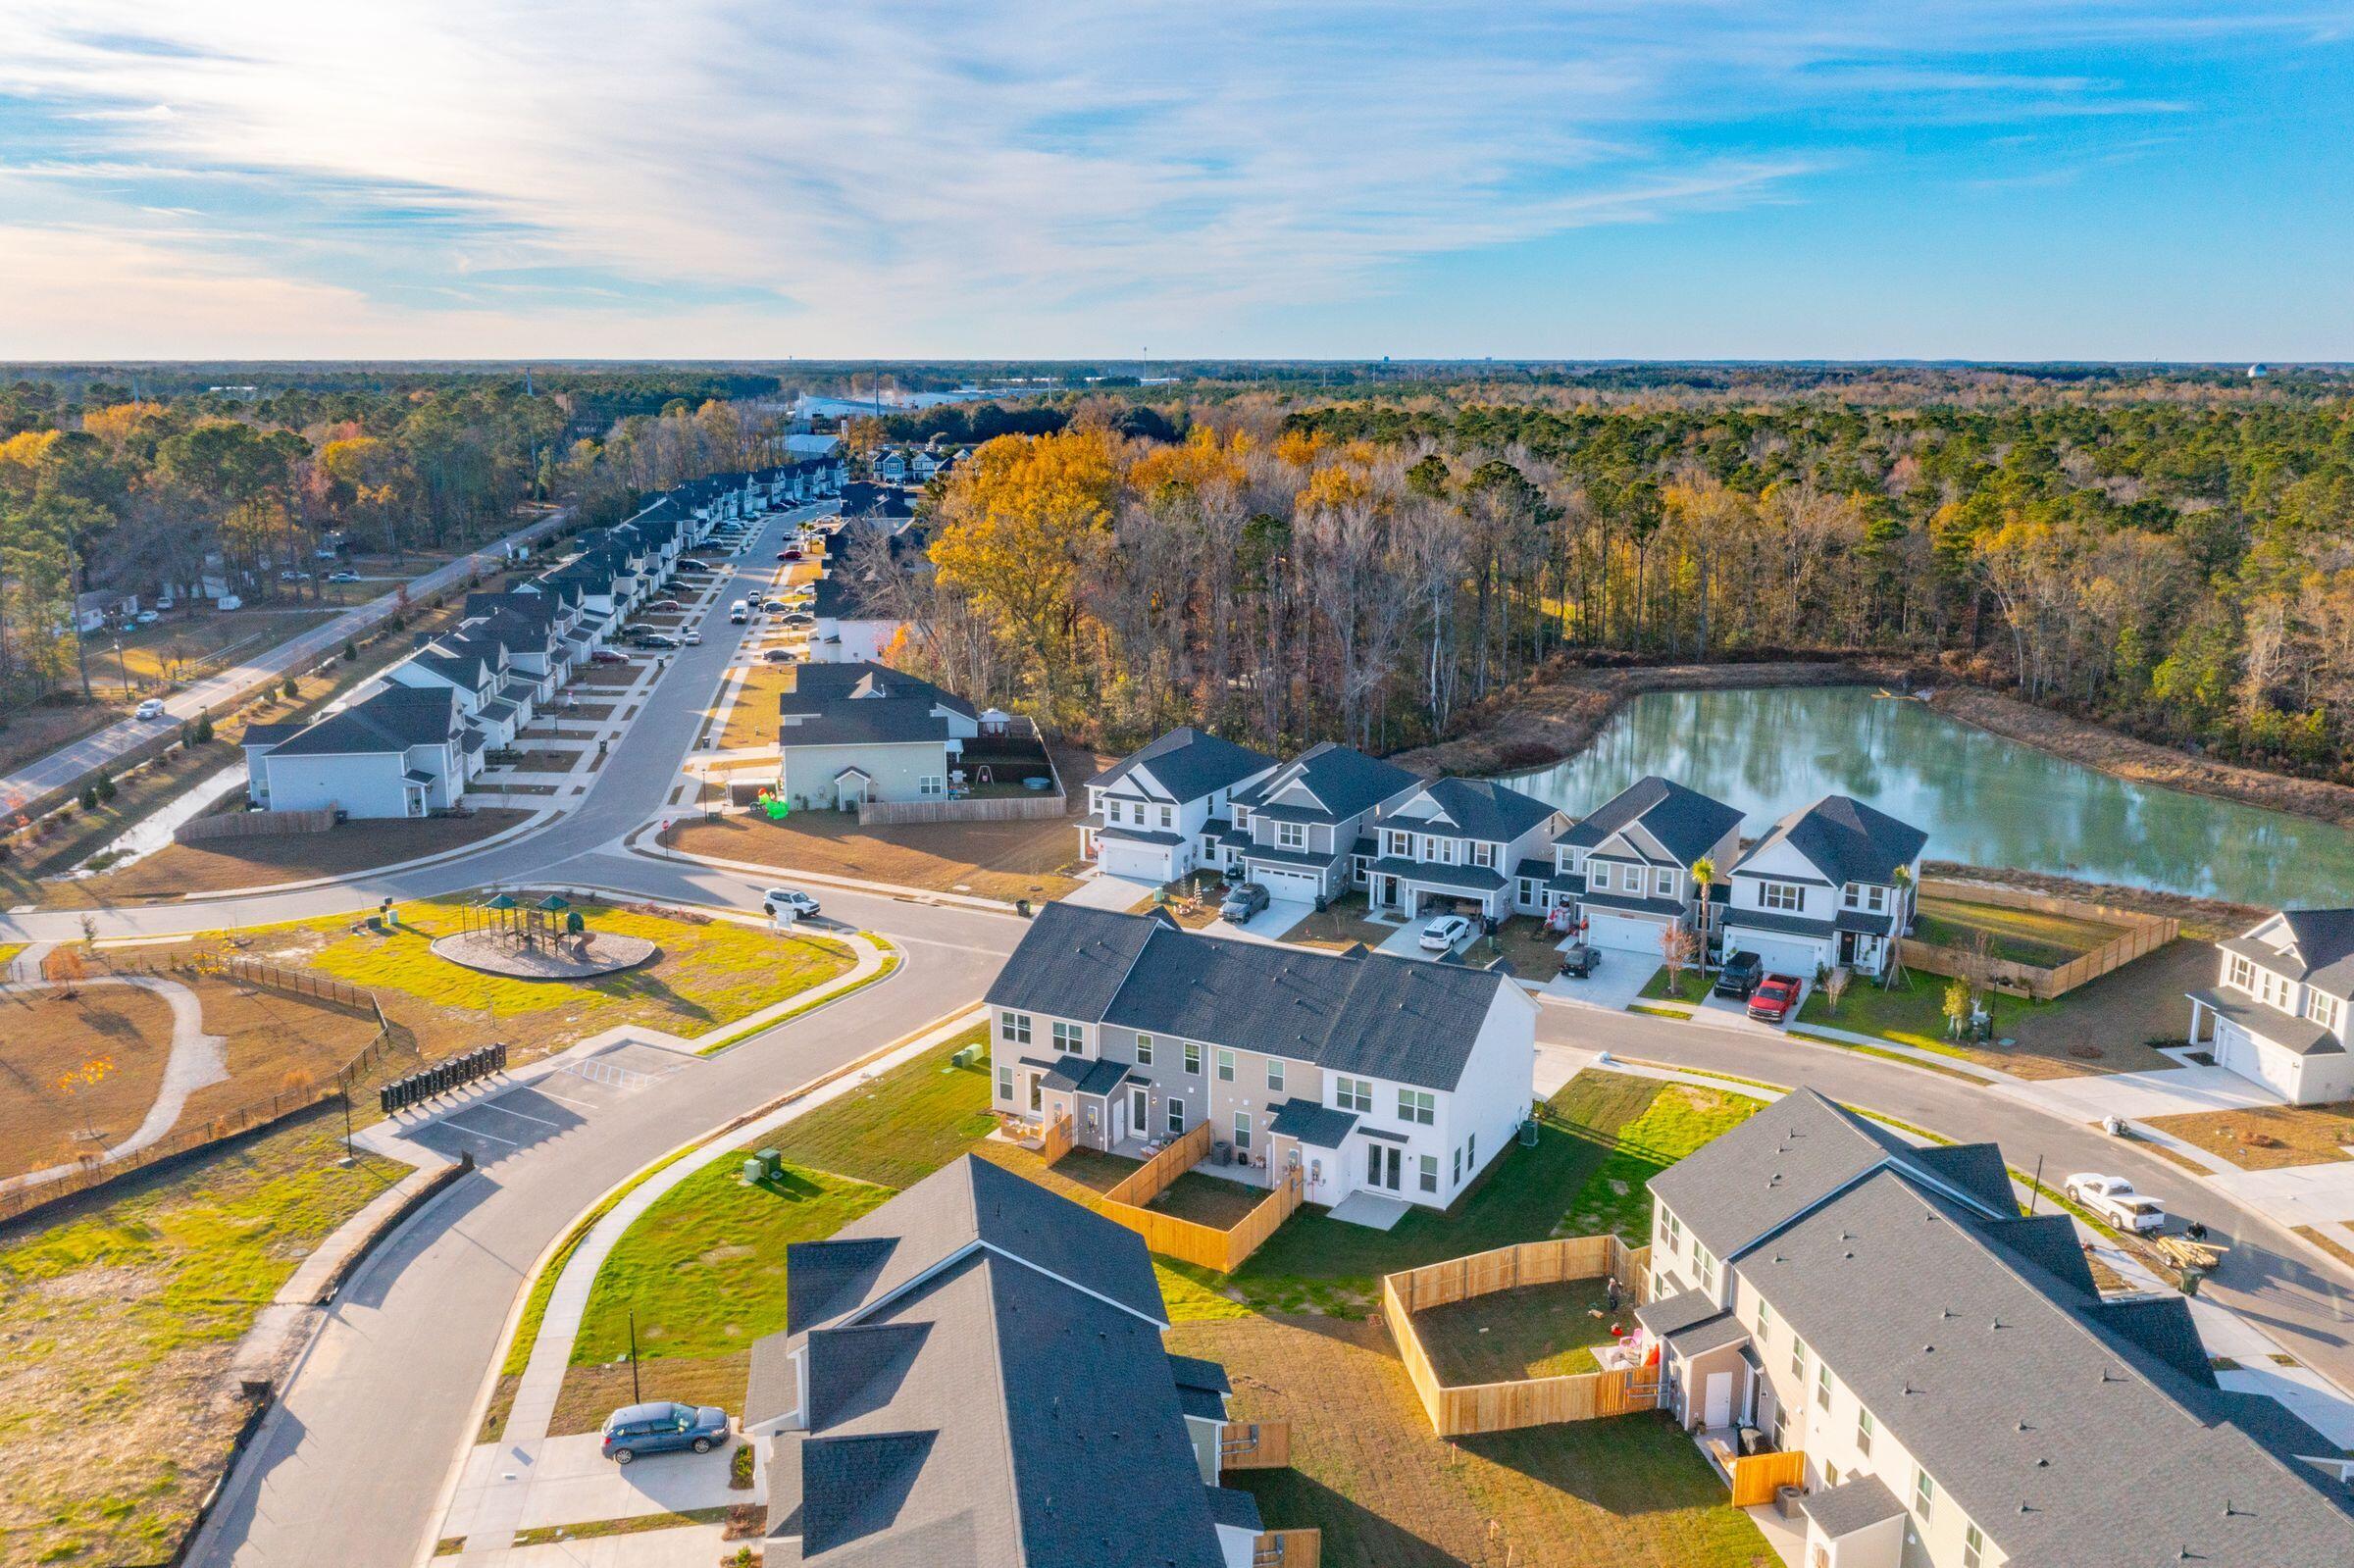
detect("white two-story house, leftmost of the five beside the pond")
[1078,725,1276,883]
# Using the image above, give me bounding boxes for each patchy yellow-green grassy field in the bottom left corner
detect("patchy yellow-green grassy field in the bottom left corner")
[0,1114,402,1566]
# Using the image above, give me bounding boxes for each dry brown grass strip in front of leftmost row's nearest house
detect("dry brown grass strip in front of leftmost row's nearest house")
[42,805,530,909]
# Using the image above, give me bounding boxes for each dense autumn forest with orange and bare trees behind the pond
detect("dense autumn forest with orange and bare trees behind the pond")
[876,368,2354,777]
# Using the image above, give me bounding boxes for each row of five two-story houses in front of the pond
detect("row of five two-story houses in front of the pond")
[1078,730,1928,977]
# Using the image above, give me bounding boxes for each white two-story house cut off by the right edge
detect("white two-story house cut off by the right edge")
[2189,909,2354,1104]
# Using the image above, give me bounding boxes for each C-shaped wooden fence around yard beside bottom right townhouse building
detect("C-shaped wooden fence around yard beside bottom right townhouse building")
[1382,1236,1660,1437]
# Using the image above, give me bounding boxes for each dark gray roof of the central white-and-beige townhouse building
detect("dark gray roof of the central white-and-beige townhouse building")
[989,904,1509,1090]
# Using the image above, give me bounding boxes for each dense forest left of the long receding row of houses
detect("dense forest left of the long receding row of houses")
[0,370,777,711]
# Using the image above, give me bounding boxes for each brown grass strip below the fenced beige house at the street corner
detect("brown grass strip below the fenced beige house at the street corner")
[661,791,1081,902]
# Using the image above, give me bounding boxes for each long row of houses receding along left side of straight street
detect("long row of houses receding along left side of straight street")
[242,459,843,817]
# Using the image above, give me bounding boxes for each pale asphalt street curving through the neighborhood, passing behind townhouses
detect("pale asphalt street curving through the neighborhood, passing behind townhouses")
[36,513,2354,1568]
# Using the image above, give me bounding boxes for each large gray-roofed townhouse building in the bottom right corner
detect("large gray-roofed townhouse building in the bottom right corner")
[1624,1090,2354,1568]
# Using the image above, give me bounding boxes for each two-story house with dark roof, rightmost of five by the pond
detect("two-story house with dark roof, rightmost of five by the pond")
[1723,796,1928,980]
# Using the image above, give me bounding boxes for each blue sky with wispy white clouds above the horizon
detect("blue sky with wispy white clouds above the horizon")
[0,0,2354,360]
